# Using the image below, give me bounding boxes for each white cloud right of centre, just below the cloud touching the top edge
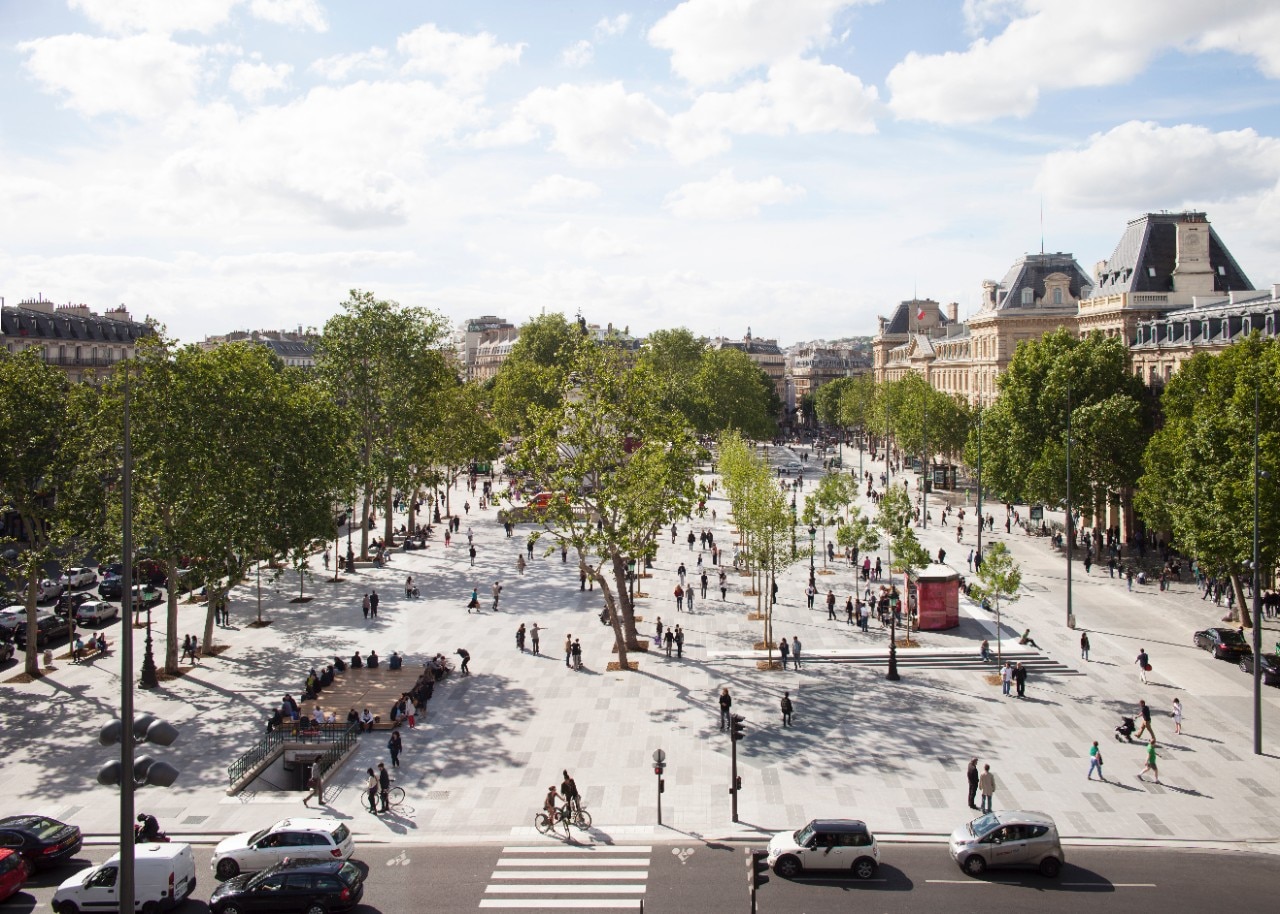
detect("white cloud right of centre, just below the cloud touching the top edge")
[671,59,879,161]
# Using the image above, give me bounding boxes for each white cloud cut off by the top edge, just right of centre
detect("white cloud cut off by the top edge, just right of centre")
[649,0,874,86]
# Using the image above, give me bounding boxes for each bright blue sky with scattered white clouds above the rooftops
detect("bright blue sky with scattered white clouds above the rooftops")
[0,0,1280,344]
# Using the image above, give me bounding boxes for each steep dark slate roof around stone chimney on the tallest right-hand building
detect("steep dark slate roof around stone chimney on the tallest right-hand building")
[1094,212,1253,296]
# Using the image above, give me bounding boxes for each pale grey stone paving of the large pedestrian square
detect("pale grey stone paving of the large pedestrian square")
[0,440,1280,844]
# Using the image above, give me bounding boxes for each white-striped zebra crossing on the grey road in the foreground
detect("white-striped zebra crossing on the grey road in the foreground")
[480,845,653,911]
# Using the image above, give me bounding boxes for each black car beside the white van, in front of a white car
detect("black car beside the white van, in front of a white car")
[209,858,365,914]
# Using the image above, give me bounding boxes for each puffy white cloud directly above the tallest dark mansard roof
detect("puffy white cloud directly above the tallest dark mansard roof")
[1039,120,1280,210]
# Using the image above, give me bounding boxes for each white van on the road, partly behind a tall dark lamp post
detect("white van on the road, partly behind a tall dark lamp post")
[52,844,196,914]
